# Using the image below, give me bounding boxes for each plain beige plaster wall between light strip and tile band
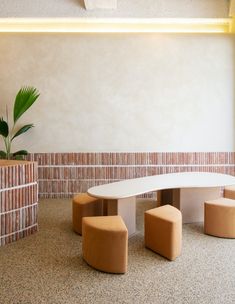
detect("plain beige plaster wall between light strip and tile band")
[0,34,234,152]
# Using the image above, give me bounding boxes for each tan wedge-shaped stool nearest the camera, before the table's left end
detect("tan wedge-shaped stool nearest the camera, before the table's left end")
[82,215,128,273]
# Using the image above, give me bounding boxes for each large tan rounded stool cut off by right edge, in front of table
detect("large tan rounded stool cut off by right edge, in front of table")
[204,197,235,238]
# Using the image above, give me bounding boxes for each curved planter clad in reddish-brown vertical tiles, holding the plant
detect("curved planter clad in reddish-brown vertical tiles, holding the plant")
[0,160,38,246]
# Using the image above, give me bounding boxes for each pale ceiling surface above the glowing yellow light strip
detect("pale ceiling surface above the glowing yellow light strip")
[0,0,229,18]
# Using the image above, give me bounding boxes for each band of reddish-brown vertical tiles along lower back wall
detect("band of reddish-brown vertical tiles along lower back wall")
[28,152,235,198]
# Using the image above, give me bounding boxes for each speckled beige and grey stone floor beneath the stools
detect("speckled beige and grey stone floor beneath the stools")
[0,199,235,304]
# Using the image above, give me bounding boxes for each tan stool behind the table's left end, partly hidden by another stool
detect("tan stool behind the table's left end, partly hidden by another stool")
[72,193,103,234]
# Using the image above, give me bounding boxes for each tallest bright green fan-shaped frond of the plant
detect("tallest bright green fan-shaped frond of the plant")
[13,87,40,123]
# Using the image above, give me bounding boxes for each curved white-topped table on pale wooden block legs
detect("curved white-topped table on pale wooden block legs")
[87,172,235,235]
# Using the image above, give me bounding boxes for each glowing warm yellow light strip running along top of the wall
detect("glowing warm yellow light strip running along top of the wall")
[0,18,233,33]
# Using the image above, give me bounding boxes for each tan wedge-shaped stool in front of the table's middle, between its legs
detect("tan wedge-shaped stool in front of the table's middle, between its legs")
[144,205,182,260]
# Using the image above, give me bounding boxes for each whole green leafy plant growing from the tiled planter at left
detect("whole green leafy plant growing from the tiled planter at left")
[0,87,40,159]
